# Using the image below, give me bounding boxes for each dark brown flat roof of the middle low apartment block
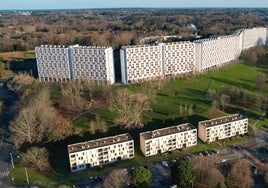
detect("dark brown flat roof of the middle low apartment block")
[140,123,196,140]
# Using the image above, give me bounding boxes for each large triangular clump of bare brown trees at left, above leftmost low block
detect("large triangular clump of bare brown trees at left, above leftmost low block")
[10,87,69,147]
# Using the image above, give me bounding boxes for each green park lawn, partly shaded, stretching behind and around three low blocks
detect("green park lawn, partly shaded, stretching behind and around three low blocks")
[8,47,268,186]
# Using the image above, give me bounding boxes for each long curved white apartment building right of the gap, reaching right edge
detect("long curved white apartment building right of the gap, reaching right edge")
[120,27,267,84]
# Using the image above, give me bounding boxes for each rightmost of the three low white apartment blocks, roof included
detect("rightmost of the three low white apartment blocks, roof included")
[198,114,248,143]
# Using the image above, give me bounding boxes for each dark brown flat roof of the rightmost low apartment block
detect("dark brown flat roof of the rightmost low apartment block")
[198,114,246,127]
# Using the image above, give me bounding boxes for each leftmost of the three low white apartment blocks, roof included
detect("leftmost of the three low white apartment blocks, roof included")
[68,134,134,172]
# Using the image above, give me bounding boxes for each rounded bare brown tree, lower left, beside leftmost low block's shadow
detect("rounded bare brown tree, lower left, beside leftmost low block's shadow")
[22,147,51,172]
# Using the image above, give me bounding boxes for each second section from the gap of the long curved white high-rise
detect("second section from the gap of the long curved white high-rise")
[163,42,195,76]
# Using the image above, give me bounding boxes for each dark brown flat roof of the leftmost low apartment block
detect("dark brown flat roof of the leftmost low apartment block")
[68,133,133,154]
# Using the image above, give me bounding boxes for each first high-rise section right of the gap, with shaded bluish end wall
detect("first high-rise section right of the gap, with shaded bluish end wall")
[120,44,163,84]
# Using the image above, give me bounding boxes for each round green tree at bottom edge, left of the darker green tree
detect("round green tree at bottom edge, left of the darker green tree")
[131,167,152,187]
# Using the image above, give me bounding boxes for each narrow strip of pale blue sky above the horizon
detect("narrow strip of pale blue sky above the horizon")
[0,0,268,10]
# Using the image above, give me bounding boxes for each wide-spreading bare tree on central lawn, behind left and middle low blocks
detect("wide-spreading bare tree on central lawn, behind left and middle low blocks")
[110,89,152,129]
